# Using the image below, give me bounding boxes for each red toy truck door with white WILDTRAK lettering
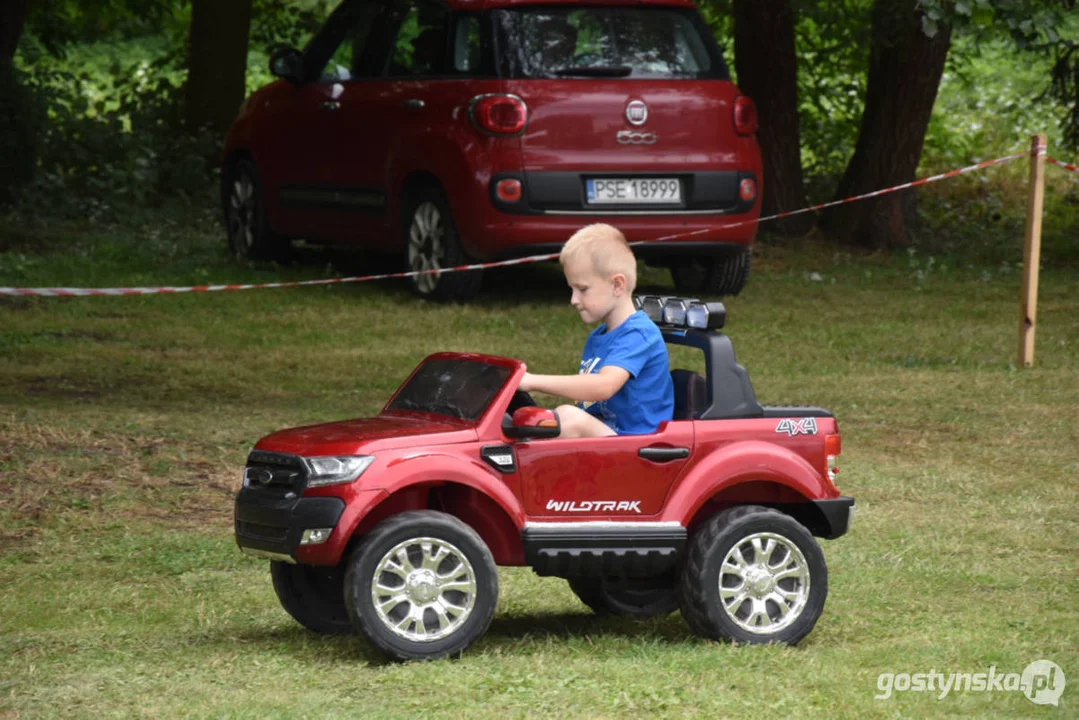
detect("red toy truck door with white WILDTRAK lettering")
[516,421,693,520]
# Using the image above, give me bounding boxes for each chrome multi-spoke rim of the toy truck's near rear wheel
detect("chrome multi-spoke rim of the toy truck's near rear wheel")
[720,532,809,635]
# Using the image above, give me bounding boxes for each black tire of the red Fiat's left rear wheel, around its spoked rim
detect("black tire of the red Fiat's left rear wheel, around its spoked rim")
[401,186,483,302]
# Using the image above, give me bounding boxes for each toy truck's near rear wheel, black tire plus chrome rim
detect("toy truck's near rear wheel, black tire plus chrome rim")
[680,505,828,646]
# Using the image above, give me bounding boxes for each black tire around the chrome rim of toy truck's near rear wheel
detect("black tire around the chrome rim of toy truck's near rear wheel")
[680,505,828,646]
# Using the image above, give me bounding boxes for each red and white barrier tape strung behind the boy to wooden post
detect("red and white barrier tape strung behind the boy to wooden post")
[0,152,1027,297]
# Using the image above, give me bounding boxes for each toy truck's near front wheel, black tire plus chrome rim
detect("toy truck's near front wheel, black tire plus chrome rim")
[344,511,498,661]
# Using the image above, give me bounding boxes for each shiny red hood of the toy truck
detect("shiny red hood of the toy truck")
[256,413,476,457]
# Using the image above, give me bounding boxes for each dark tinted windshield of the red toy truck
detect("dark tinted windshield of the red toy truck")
[386,358,510,420]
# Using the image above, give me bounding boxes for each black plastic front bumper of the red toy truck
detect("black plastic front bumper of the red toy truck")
[234,487,344,562]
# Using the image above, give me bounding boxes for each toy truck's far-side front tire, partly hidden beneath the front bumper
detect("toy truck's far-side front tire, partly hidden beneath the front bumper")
[270,561,354,635]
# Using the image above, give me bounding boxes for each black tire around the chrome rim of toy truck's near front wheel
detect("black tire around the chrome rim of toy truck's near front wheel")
[344,511,498,661]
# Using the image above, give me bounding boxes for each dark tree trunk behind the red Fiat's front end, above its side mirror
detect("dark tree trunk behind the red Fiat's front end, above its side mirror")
[185,0,251,138]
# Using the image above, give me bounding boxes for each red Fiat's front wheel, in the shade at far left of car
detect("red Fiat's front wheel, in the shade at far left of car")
[221,158,288,260]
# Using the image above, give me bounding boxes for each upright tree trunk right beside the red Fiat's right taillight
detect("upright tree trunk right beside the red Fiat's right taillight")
[734,0,814,235]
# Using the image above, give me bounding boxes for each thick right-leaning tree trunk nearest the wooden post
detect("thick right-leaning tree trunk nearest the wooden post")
[821,0,952,249]
